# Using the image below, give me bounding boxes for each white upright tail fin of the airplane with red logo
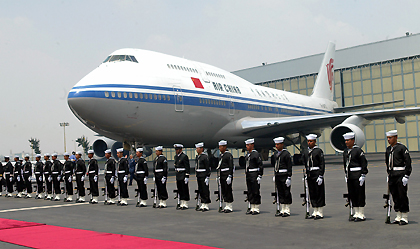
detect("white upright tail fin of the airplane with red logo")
[311,42,335,100]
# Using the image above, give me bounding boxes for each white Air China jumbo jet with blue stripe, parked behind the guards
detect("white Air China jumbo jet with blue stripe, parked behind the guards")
[68,42,420,162]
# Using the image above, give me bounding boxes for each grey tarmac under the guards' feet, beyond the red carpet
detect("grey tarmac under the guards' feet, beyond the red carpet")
[0,153,420,248]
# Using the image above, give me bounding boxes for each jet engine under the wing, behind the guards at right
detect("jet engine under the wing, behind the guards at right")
[330,116,368,153]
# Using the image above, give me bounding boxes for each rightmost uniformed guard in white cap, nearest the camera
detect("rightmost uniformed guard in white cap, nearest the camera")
[385,130,411,225]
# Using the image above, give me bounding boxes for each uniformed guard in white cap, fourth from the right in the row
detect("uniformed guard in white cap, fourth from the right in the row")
[273,137,292,217]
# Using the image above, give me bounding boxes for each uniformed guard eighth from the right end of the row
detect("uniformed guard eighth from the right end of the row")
[174,144,190,209]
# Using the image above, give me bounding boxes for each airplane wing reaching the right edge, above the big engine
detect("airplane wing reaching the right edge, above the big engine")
[238,107,420,137]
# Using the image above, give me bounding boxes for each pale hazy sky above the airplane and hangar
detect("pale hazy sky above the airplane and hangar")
[0,0,420,155]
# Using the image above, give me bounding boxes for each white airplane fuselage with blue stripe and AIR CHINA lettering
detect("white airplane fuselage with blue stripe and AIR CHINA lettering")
[68,49,337,148]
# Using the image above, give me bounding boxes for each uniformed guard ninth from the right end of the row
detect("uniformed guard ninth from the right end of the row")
[153,146,168,208]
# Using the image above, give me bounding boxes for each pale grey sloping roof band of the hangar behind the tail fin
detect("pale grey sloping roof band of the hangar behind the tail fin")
[232,34,420,83]
